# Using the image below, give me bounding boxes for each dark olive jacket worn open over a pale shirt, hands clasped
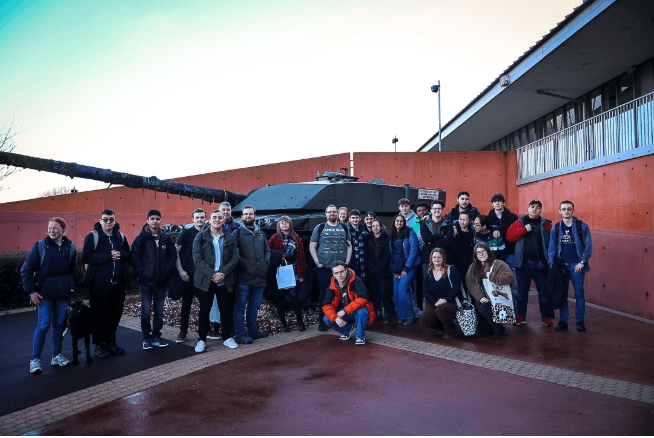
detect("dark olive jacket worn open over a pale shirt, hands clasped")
[193,228,241,292]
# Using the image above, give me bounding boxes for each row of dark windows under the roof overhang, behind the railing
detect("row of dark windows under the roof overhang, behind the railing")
[482,58,654,151]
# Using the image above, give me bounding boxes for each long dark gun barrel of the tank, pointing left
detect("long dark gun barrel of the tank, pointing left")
[0,152,247,206]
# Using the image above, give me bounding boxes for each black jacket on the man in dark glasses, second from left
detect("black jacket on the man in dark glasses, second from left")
[82,222,130,286]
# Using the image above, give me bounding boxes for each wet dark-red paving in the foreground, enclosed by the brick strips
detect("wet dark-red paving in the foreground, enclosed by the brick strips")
[38,336,654,435]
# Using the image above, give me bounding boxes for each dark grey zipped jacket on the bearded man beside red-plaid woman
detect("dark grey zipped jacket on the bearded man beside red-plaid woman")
[232,224,270,286]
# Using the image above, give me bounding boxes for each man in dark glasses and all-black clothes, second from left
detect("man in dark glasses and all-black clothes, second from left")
[82,208,130,359]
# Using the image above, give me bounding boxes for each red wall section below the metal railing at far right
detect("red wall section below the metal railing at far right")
[518,155,654,319]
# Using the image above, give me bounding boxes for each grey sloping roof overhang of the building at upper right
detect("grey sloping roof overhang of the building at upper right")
[418,0,654,152]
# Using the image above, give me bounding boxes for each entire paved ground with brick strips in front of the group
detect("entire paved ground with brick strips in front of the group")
[0,298,654,435]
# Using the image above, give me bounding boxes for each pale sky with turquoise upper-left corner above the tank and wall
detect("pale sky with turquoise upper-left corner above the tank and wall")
[0,0,581,203]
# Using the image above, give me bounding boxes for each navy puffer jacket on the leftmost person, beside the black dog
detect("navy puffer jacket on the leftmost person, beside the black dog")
[20,236,77,300]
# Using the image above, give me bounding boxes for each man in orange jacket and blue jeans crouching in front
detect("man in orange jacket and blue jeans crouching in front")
[322,261,375,345]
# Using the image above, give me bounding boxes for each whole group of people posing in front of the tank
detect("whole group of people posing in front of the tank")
[21,191,592,373]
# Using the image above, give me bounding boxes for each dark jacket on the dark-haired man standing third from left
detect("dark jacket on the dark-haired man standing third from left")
[131,224,177,287]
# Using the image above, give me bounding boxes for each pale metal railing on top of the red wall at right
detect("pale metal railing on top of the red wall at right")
[518,93,654,179]
